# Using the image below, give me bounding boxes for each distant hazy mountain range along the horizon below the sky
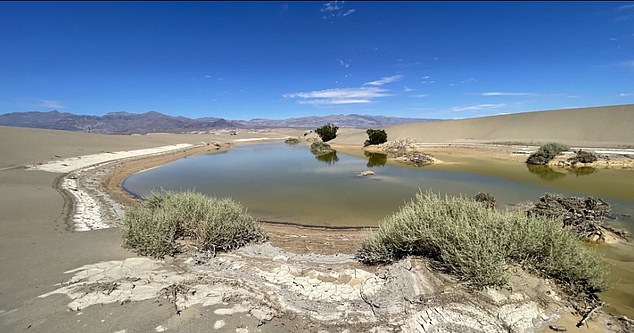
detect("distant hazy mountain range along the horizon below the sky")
[0,111,435,134]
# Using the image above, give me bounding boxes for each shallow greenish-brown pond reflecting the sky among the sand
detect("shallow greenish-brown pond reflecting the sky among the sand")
[124,143,634,317]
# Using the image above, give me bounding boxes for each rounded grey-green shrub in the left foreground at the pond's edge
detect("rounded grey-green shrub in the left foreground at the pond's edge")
[123,192,266,258]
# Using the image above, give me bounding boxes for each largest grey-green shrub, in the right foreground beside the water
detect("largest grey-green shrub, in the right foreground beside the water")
[356,192,606,292]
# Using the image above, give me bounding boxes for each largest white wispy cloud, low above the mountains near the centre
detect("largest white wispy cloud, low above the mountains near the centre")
[282,87,390,105]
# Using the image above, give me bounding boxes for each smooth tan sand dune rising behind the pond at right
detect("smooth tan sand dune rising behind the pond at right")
[333,105,634,147]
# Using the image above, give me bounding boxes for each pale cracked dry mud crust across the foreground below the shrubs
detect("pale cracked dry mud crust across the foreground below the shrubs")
[40,243,558,332]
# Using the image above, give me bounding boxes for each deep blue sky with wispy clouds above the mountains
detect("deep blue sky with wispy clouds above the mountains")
[0,2,634,119]
